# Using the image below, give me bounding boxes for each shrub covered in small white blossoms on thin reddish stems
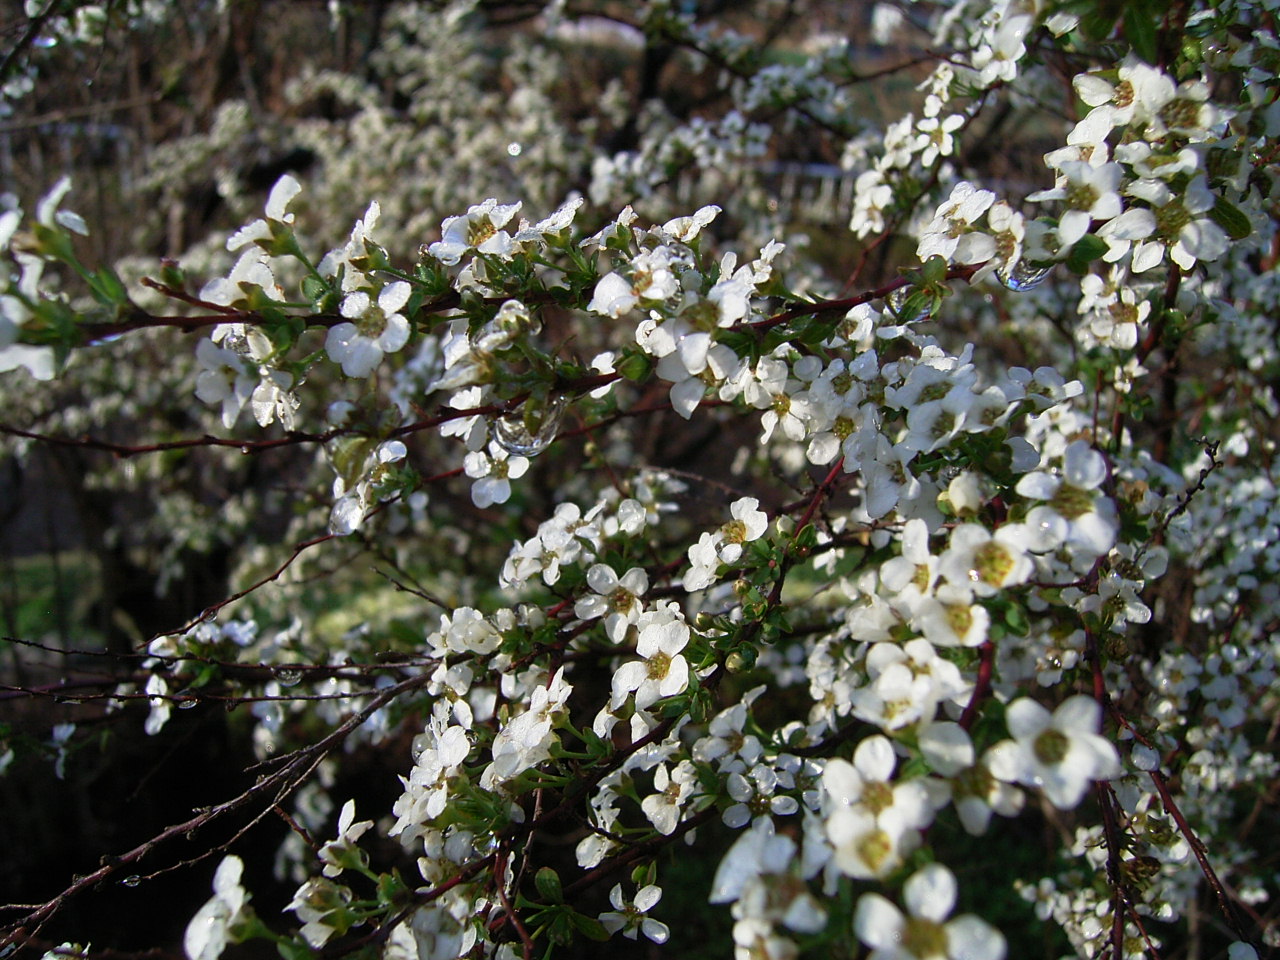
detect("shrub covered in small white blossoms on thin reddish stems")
[0,0,1280,960]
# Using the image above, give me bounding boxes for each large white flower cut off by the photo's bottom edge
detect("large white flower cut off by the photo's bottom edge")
[854,863,1005,960]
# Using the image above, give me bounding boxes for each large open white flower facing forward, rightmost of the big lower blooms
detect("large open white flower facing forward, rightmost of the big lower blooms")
[989,695,1121,810]
